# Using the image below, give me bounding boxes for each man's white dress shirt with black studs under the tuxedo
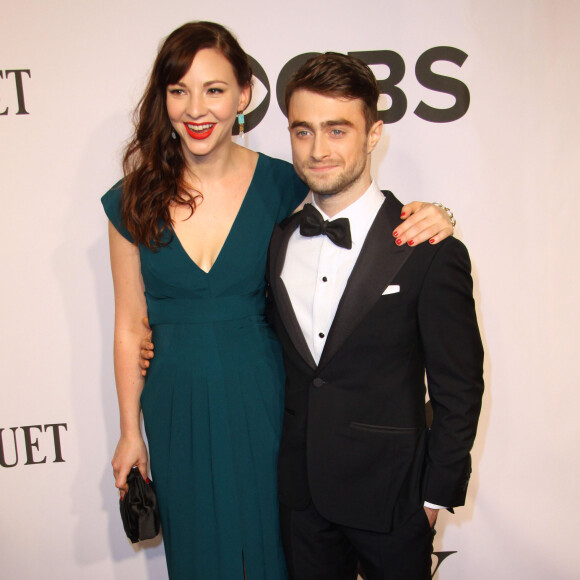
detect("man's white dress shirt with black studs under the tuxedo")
[281,181,443,509]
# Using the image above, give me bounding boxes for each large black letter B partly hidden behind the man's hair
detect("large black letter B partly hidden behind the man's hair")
[348,50,407,124]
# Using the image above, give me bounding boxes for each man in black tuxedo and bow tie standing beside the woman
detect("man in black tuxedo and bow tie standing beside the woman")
[269,53,483,580]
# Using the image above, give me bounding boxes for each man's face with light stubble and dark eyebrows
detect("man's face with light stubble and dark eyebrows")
[288,89,382,195]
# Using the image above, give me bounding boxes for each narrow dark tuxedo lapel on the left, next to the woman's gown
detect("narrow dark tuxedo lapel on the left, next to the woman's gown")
[270,213,316,369]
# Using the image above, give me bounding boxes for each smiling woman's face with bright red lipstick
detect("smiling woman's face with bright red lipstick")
[167,48,250,163]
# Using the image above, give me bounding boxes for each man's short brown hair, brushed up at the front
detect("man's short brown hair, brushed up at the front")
[284,52,380,132]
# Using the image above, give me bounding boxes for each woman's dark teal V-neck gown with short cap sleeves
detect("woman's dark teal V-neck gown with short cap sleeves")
[102,154,307,580]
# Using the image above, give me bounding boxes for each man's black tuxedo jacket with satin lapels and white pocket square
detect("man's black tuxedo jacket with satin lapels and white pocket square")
[268,192,483,532]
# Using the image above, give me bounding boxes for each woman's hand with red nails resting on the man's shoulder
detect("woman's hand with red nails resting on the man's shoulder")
[393,201,453,246]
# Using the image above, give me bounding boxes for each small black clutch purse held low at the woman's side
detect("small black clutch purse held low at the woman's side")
[119,467,160,543]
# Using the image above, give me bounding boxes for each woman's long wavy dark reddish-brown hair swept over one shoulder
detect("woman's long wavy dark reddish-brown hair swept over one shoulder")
[122,22,252,249]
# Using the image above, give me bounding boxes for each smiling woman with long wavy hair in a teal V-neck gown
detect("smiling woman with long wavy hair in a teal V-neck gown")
[102,22,450,580]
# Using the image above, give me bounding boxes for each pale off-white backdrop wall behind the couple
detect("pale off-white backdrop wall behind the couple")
[0,0,580,580]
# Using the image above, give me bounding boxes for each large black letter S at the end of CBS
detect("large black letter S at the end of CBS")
[415,46,470,123]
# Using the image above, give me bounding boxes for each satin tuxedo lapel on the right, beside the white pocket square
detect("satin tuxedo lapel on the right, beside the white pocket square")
[319,192,413,368]
